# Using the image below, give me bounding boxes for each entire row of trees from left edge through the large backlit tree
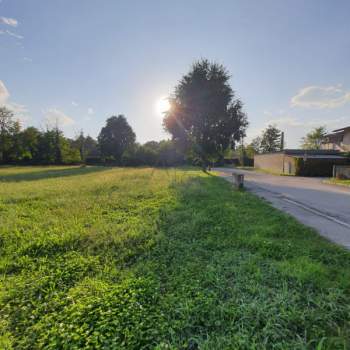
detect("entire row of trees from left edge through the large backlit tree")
[0,59,252,168]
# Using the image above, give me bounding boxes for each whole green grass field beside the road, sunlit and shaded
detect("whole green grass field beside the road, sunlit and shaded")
[0,167,350,350]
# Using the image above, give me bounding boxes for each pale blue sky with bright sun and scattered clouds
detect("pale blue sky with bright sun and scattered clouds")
[0,0,350,148]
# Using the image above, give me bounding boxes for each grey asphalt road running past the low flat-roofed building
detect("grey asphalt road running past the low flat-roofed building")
[213,168,350,249]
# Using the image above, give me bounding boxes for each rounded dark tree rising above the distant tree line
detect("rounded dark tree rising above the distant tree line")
[98,115,136,163]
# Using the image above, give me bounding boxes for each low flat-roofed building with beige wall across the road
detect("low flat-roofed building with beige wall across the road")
[254,149,349,176]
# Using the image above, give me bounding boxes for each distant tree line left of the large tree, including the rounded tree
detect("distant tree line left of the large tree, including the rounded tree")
[0,107,185,166]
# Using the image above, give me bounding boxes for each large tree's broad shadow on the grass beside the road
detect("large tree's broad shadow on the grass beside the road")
[133,176,350,349]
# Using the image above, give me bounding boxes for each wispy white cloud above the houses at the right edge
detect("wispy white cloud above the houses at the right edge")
[291,86,350,109]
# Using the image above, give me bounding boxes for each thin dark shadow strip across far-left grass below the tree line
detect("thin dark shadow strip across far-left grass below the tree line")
[0,166,110,182]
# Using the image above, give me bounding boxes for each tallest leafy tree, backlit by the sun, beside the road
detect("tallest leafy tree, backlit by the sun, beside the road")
[163,60,248,166]
